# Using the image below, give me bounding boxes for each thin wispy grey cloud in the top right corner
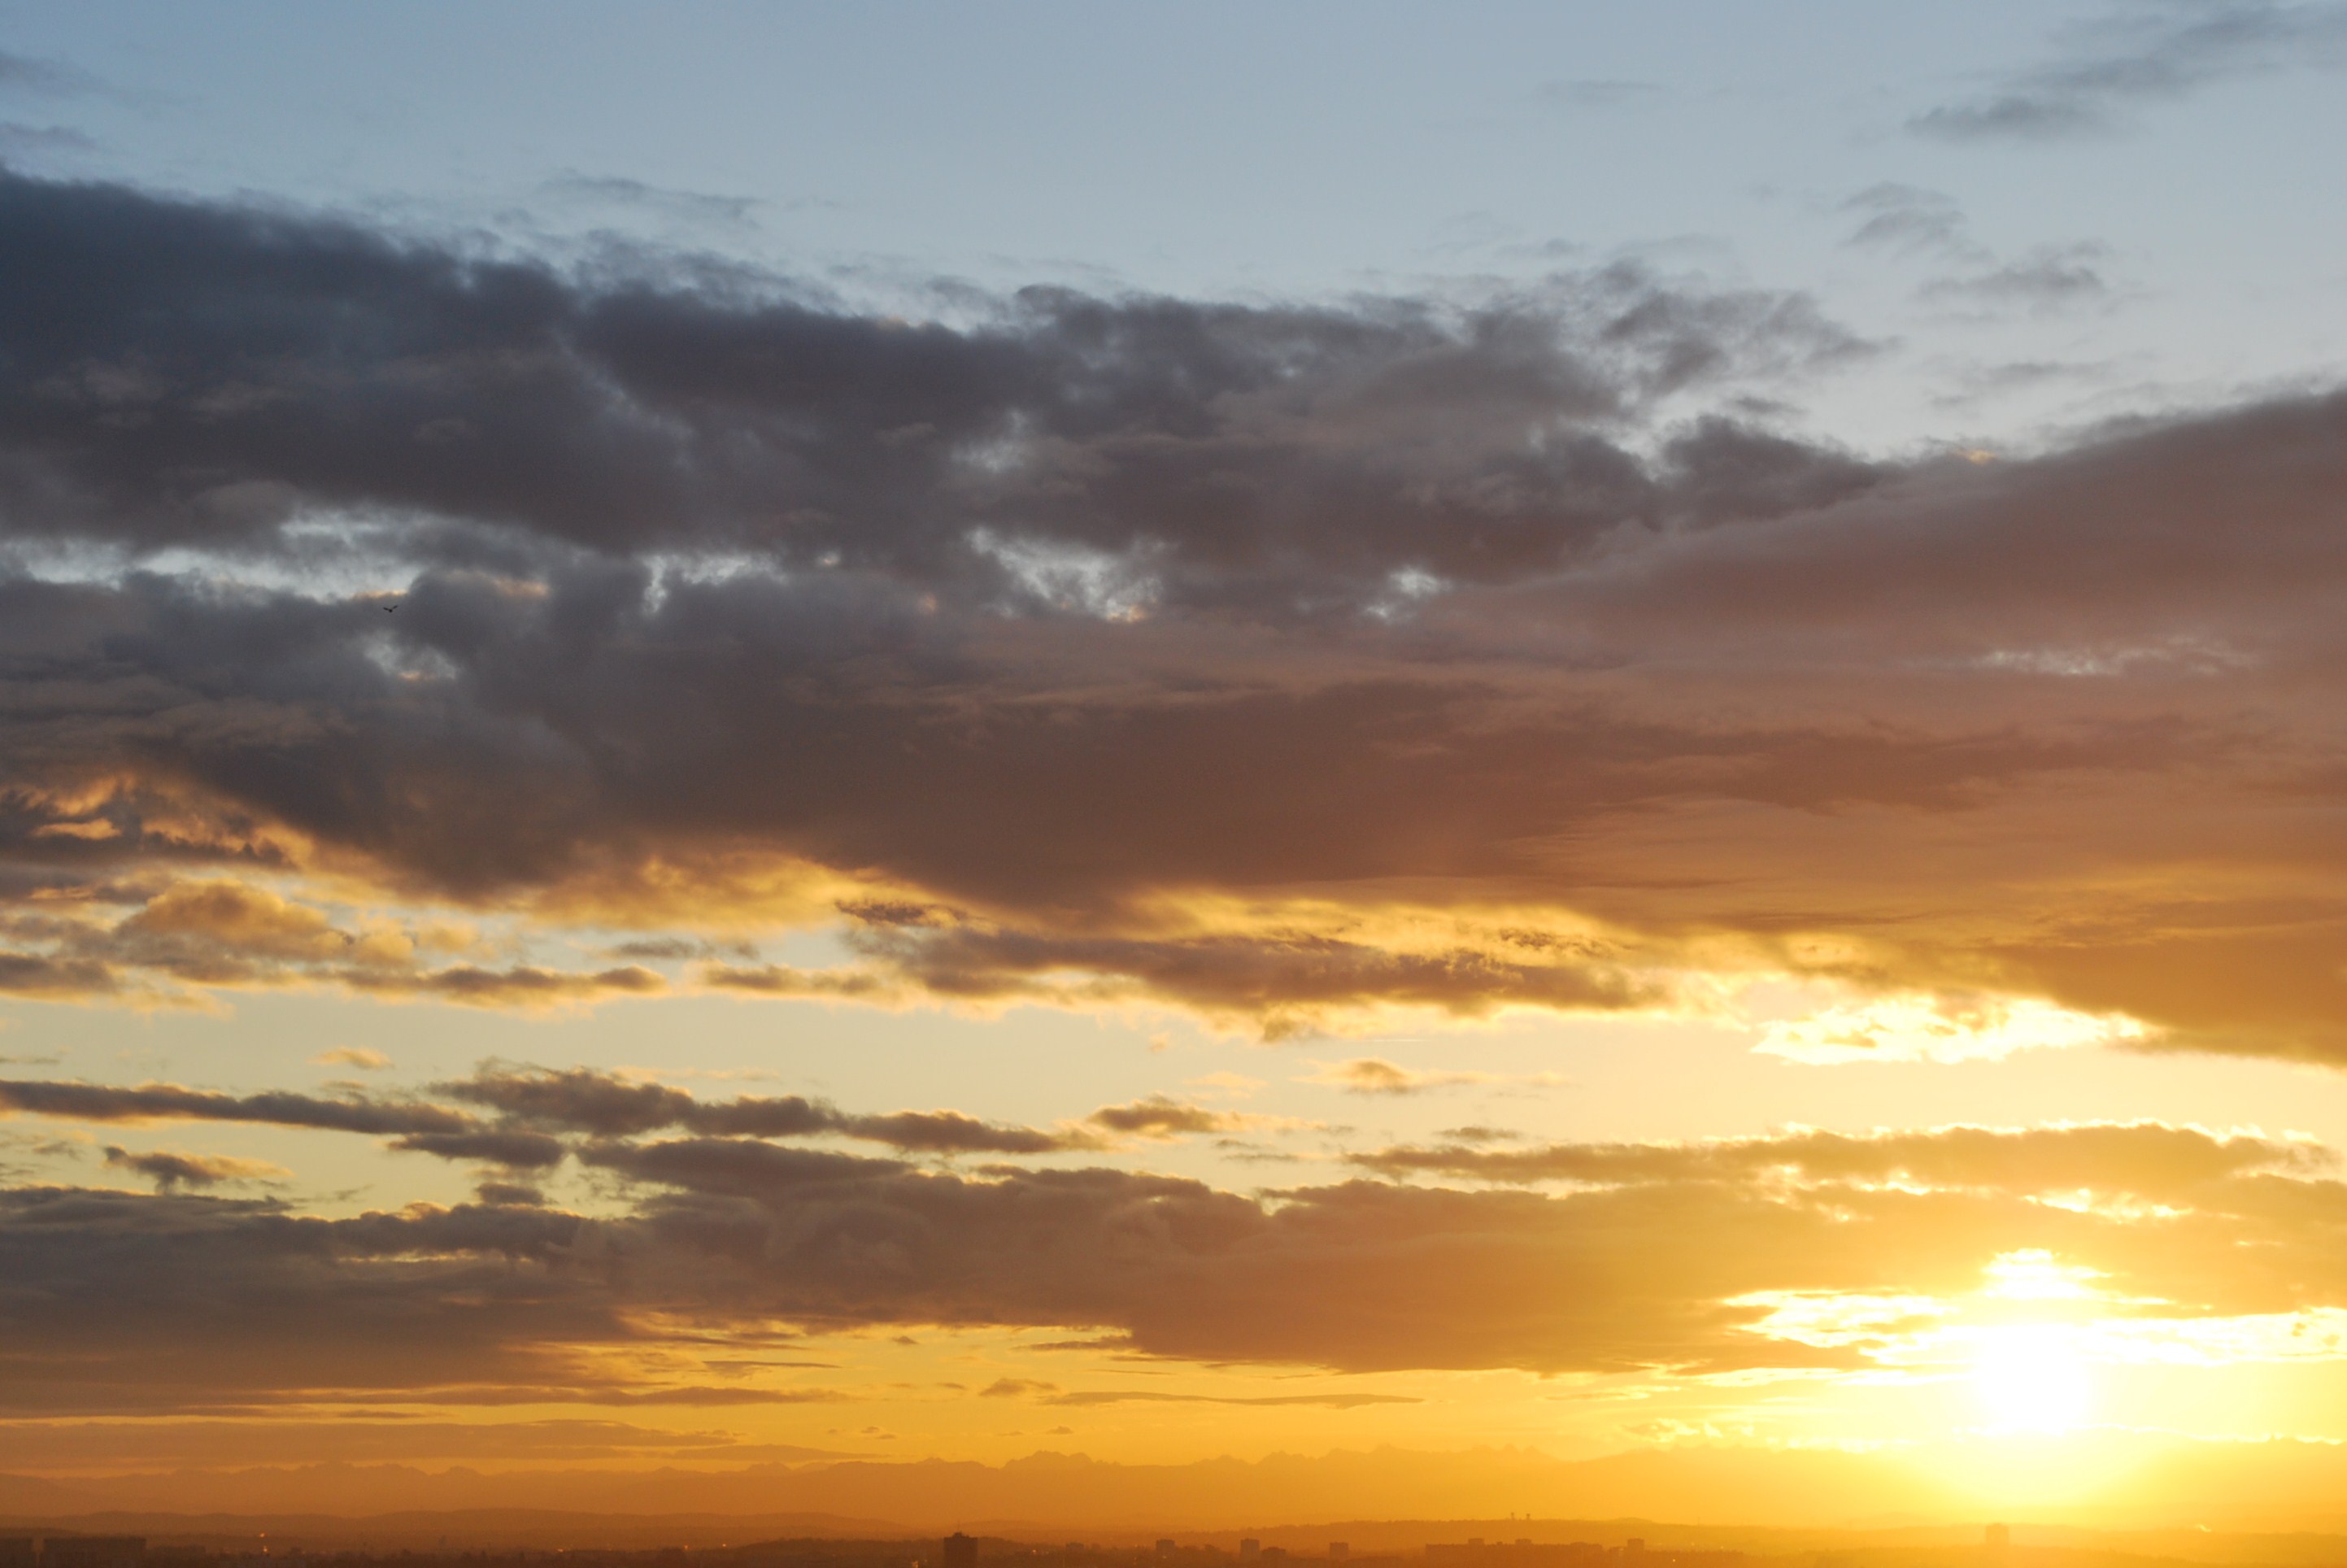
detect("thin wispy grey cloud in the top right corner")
[1908,0,2347,141]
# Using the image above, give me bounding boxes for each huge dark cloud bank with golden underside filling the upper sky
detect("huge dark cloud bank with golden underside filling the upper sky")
[0,165,2347,1061]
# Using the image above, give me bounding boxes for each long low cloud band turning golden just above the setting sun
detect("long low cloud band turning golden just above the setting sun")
[558,1125,2347,1371]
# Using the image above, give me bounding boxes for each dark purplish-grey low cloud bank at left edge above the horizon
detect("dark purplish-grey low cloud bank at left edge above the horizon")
[0,1187,631,1409]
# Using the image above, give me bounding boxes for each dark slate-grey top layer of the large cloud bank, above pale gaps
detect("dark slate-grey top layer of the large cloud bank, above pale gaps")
[0,165,1857,596]
